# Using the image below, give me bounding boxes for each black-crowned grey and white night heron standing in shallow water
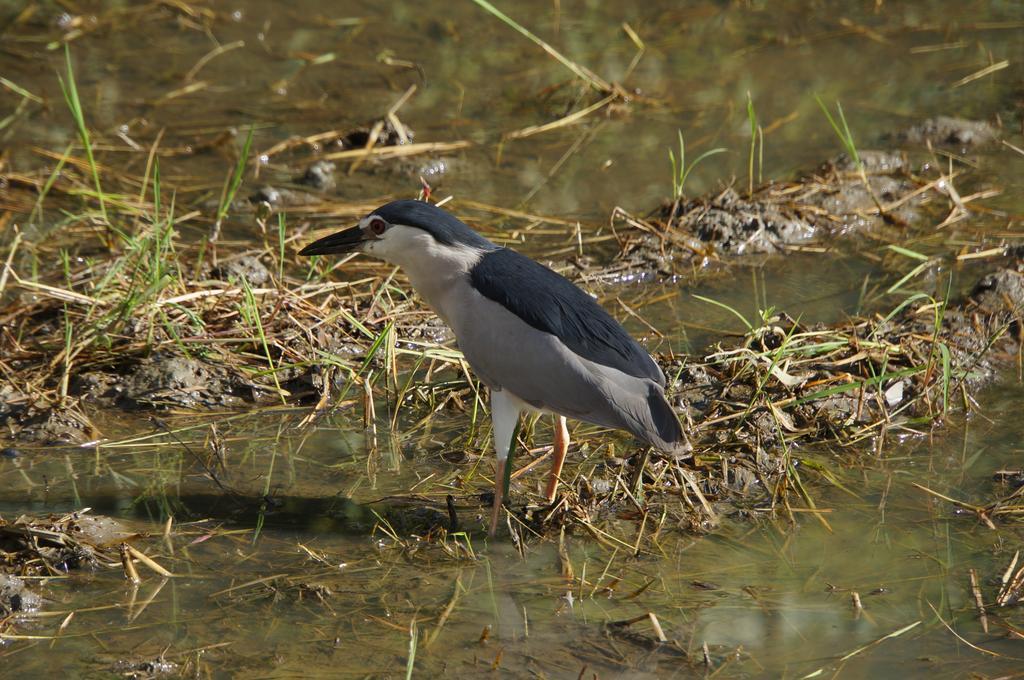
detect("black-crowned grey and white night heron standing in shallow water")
[299,200,688,537]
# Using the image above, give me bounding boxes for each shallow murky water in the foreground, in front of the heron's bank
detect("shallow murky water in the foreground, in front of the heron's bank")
[6,384,1024,677]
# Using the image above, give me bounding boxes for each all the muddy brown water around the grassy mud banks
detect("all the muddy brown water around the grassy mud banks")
[0,2,1024,678]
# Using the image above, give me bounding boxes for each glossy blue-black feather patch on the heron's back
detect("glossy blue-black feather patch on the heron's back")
[470,248,663,385]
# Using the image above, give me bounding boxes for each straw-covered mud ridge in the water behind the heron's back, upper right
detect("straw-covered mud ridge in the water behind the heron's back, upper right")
[606,151,945,281]
